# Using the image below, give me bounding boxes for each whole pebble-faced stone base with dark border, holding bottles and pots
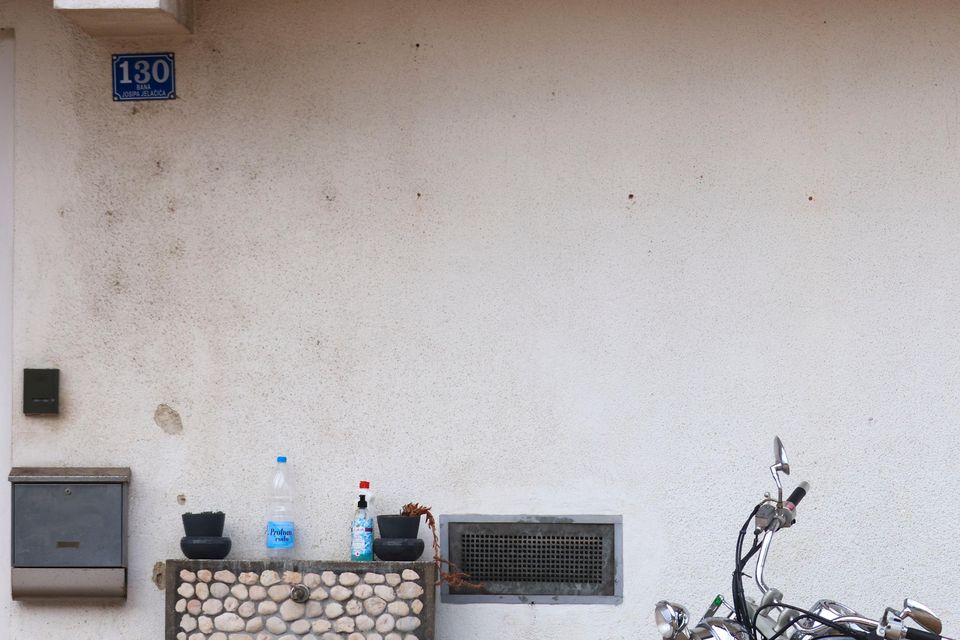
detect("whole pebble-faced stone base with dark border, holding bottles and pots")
[164,560,436,640]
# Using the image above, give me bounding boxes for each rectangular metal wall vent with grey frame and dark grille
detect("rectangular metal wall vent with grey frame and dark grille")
[440,514,623,604]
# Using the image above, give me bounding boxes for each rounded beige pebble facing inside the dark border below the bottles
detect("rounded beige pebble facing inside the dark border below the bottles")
[174,569,432,640]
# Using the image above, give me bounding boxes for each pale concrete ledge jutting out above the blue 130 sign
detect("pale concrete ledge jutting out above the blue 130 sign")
[53,0,193,37]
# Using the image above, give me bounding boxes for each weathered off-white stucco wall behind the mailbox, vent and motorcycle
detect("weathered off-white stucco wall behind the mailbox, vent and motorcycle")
[0,0,960,640]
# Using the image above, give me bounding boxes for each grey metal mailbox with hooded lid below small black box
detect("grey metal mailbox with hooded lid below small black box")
[9,467,130,600]
